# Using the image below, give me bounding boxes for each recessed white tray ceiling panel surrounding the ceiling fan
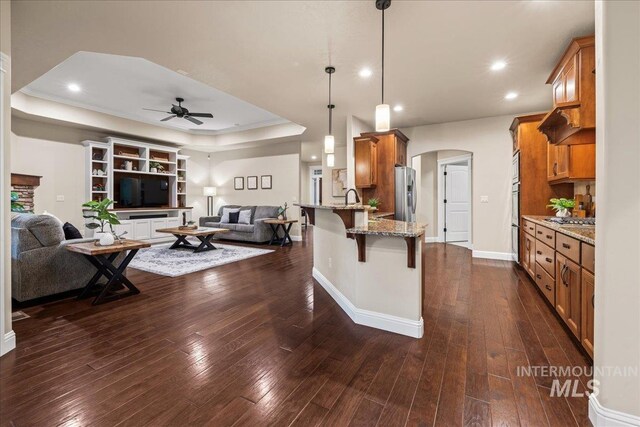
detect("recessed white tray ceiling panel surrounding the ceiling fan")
[22,52,288,134]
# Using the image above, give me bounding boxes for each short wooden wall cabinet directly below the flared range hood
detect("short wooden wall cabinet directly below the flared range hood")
[547,143,596,184]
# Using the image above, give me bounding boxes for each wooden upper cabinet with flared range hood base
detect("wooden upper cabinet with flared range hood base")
[538,36,596,145]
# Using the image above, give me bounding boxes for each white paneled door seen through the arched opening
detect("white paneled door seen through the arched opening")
[444,164,471,242]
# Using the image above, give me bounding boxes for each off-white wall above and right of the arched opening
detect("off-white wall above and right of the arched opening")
[402,115,513,257]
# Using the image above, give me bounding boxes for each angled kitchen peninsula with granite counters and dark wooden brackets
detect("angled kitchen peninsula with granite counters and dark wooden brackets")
[297,204,425,338]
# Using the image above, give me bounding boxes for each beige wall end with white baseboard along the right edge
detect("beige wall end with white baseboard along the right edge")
[590,1,640,425]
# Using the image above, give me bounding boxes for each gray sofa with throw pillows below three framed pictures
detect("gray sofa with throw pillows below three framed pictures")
[200,205,278,243]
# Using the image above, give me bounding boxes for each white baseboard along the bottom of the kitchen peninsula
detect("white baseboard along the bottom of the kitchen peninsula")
[313,267,424,338]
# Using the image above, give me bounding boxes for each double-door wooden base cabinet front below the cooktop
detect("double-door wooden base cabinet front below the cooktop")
[556,253,582,339]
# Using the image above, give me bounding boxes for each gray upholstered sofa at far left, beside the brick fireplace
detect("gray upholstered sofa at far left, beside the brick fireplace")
[11,213,96,302]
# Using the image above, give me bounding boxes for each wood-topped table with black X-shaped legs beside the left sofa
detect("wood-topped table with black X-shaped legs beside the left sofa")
[66,240,151,305]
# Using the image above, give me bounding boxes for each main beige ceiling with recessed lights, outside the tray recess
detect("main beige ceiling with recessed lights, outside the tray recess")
[12,0,594,160]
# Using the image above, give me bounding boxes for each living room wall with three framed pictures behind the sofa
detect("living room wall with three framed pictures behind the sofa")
[211,143,300,236]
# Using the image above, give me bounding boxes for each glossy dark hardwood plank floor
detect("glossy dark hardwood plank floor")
[0,233,589,426]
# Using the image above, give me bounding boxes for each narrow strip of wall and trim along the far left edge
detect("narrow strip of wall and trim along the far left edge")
[0,1,12,355]
